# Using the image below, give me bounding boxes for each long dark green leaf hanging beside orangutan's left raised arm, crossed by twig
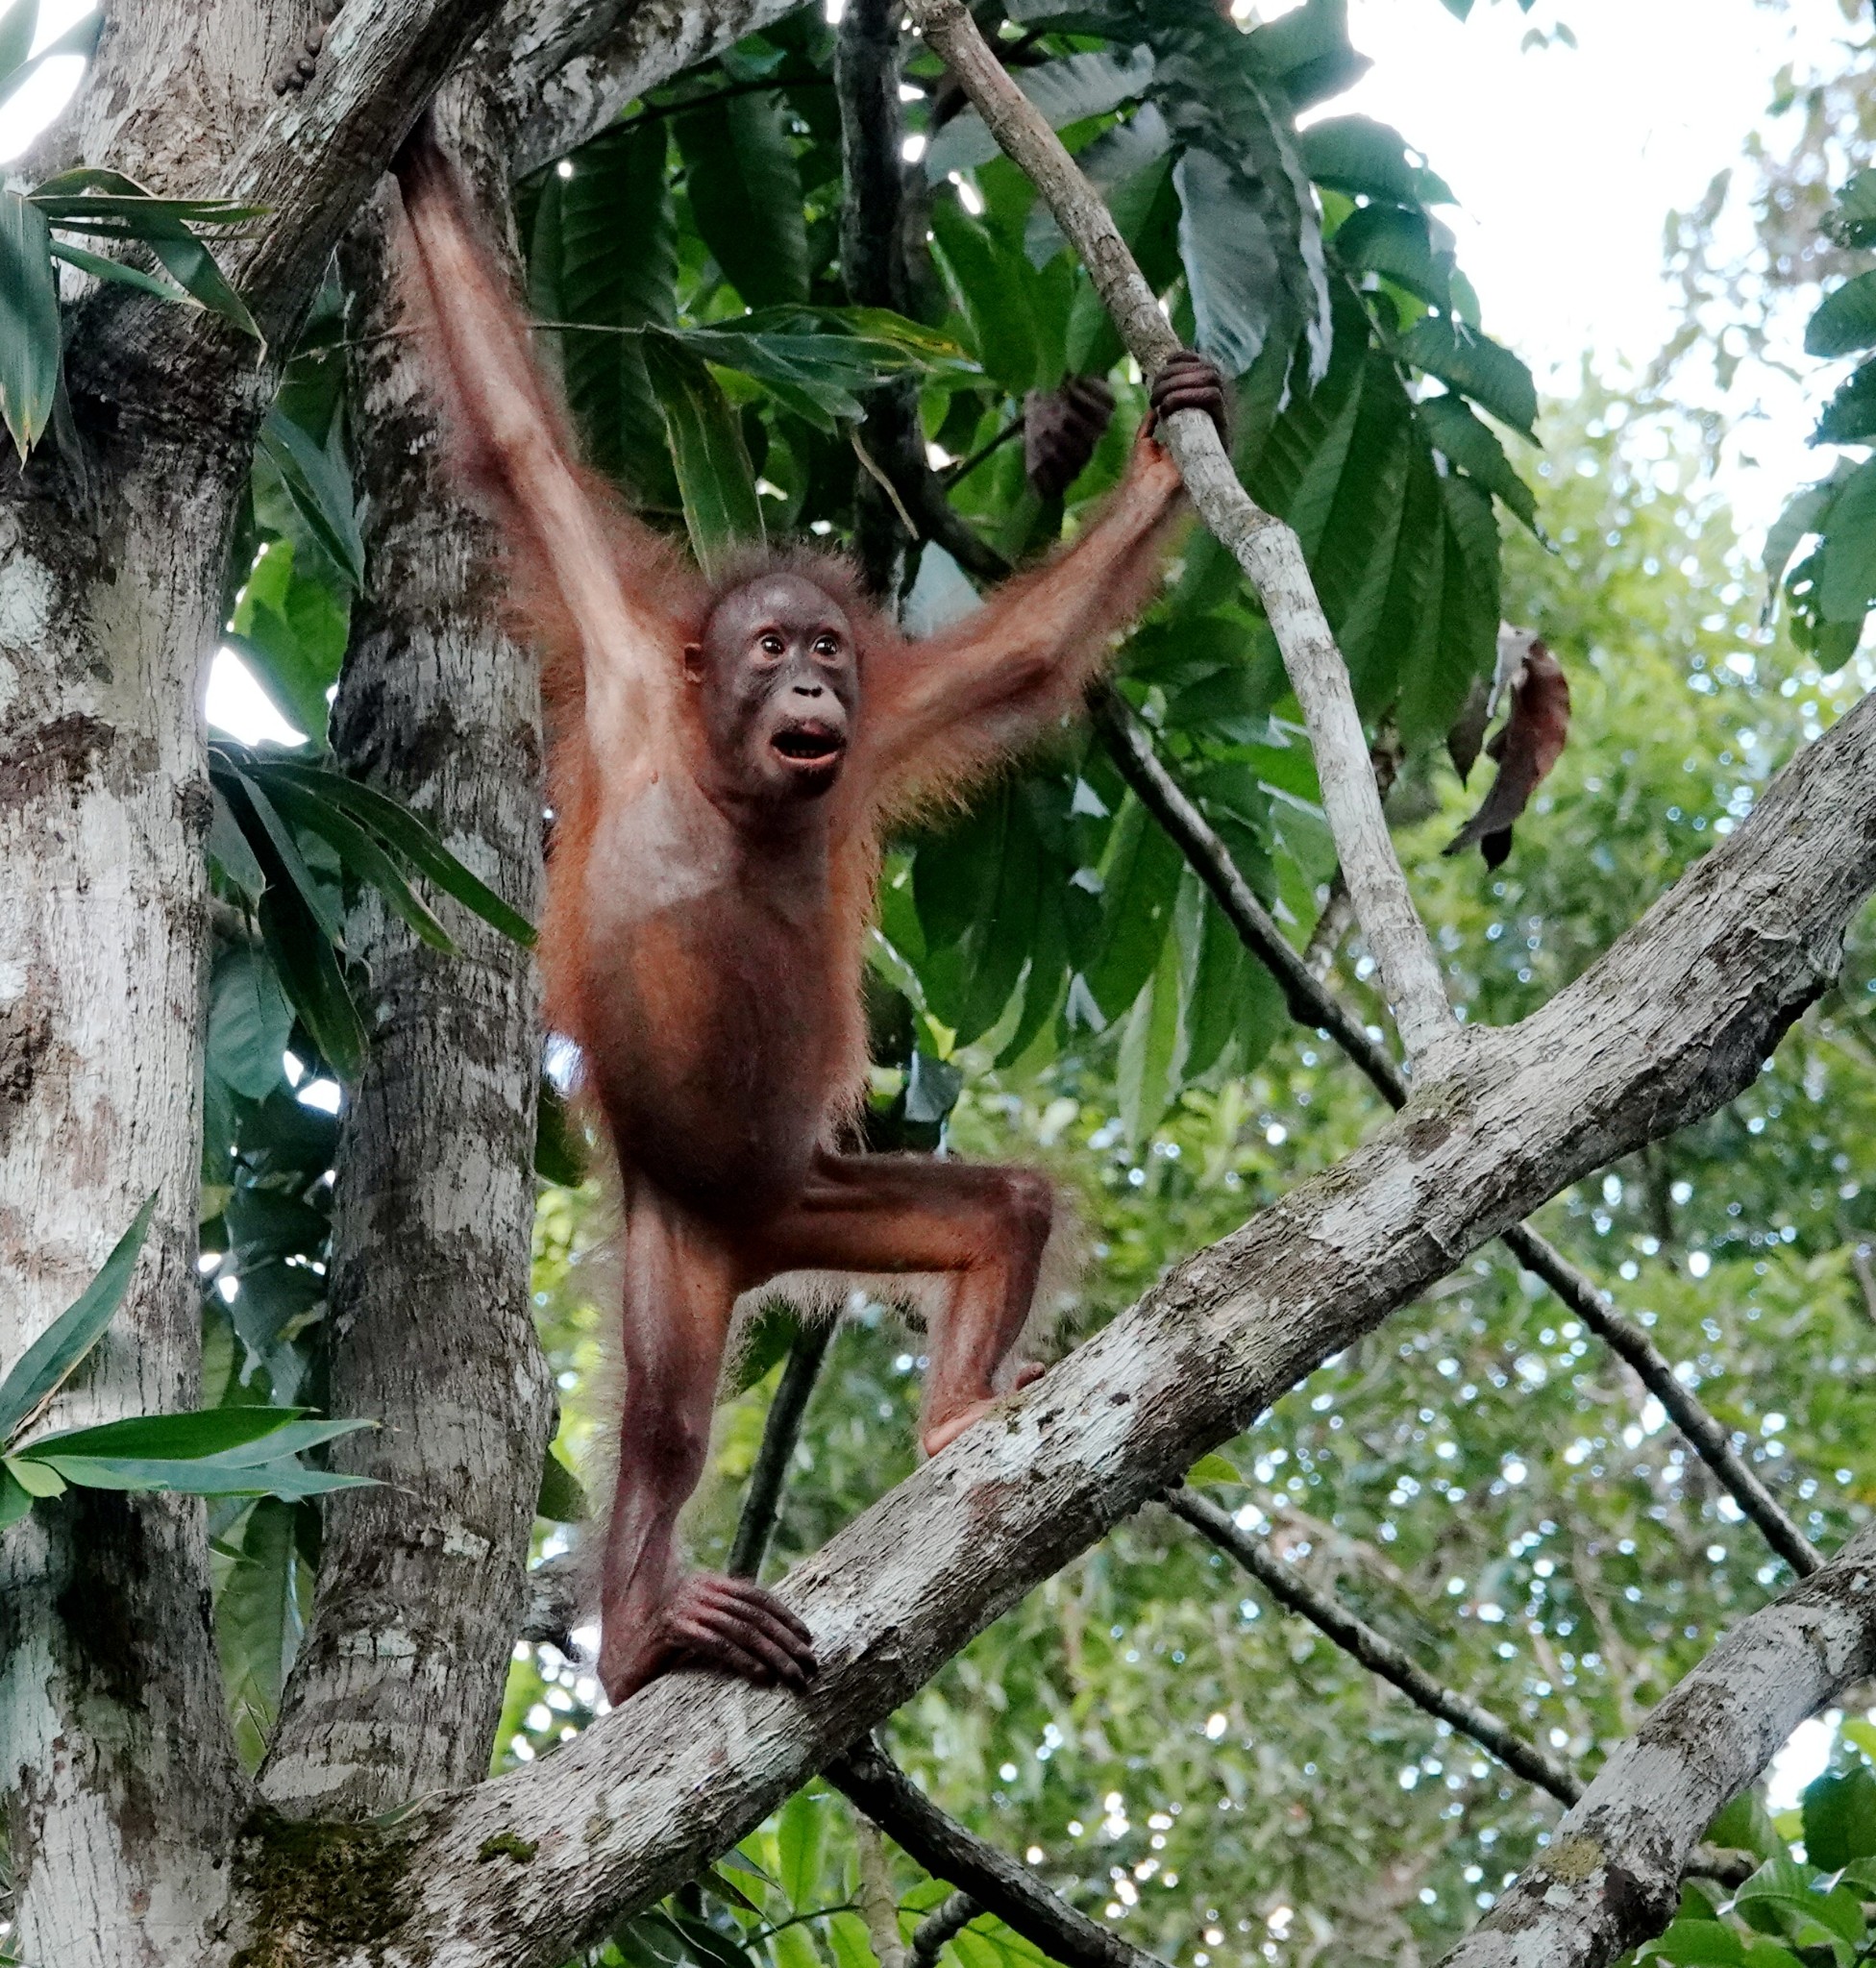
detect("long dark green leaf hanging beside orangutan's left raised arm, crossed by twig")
[528,120,679,509]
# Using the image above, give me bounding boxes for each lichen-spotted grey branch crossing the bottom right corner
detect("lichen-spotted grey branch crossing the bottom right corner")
[1444,1531,1876,1968]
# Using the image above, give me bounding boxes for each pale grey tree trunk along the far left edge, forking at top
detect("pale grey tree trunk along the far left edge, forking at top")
[0,0,527,1968]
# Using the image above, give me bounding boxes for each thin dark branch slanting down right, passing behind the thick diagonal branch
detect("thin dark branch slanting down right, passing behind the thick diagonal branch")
[1091,687,1821,1576]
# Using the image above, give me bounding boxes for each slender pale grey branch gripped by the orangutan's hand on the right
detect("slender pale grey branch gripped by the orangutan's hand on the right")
[911,0,1469,1072]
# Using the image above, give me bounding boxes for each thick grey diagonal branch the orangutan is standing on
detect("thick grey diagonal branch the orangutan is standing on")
[324,699,1876,1968]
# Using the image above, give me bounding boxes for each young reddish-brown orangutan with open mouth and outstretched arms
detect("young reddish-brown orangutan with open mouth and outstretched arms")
[398,134,1222,1700]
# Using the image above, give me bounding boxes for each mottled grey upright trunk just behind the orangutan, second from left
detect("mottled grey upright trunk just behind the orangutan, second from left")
[263,85,554,1816]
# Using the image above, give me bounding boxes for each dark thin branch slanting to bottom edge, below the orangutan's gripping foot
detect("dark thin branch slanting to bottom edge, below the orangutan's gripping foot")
[823,1735,1166,1968]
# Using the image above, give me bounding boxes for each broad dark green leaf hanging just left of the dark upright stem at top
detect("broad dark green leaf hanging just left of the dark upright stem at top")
[676,90,807,307]
